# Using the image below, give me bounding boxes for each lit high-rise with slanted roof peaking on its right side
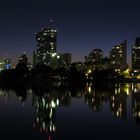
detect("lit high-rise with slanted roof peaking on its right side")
[110,41,127,70]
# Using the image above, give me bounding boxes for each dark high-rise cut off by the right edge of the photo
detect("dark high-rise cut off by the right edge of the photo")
[132,38,140,73]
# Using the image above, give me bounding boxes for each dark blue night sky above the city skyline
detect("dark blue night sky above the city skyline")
[0,0,140,63]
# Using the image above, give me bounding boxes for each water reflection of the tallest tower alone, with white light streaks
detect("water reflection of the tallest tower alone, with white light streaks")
[33,95,59,134]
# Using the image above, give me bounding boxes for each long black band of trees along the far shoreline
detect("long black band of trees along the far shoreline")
[0,63,138,88]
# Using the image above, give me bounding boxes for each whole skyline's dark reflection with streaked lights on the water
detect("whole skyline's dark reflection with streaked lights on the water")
[0,83,140,139]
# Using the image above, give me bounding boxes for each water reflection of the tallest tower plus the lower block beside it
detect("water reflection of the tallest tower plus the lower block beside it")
[32,89,71,139]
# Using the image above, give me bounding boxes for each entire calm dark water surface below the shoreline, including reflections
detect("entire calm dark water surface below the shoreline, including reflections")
[0,84,140,140]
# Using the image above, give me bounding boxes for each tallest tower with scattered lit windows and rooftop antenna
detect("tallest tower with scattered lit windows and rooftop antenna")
[36,27,57,66]
